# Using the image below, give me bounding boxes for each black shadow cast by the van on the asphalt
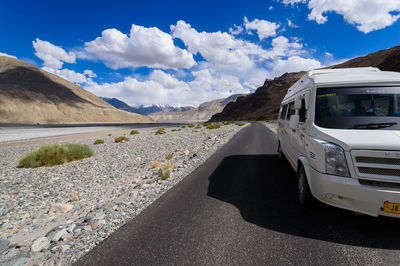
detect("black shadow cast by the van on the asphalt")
[207,155,400,249]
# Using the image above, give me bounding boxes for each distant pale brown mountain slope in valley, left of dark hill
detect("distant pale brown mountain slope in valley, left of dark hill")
[150,94,241,122]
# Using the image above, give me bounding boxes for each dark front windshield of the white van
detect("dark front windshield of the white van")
[315,87,400,130]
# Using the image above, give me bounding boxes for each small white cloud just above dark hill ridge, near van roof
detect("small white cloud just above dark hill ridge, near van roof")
[271,55,322,77]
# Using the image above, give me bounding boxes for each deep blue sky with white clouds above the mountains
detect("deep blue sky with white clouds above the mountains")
[0,0,400,106]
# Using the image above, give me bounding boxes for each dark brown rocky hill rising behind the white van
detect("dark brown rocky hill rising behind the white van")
[211,46,400,121]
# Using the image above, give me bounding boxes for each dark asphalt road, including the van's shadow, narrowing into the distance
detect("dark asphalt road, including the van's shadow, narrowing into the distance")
[77,123,400,265]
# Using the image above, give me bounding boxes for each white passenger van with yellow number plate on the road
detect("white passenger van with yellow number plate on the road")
[277,67,400,217]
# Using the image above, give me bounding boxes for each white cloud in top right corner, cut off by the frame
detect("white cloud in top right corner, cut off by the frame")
[282,0,400,33]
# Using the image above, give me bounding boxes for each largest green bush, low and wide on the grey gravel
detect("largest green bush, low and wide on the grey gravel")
[17,143,93,168]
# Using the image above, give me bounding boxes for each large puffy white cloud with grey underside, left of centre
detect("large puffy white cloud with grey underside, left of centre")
[79,25,196,69]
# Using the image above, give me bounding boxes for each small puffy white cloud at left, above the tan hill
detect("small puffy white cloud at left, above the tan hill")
[32,38,76,69]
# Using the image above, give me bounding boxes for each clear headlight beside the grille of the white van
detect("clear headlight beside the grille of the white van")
[322,143,350,177]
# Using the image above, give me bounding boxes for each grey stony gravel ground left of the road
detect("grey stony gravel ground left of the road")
[0,125,247,265]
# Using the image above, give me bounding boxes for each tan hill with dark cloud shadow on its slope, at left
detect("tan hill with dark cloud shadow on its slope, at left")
[0,56,153,124]
